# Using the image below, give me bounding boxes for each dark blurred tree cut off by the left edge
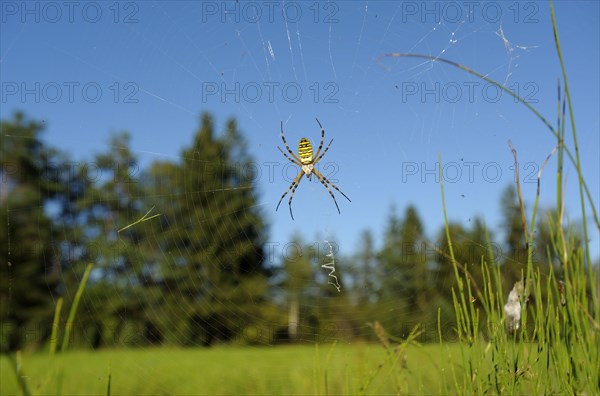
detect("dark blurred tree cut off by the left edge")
[0,114,57,351]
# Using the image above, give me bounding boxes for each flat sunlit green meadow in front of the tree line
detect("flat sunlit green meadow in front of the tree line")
[0,344,460,395]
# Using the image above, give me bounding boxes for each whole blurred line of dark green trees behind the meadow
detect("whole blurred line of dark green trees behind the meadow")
[0,113,598,352]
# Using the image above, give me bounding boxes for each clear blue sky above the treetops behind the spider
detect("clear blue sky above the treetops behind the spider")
[0,1,600,257]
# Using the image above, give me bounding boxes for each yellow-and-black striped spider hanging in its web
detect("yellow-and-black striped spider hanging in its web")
[275,119,351,220]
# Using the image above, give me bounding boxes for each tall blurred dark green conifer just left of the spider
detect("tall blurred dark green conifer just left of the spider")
[141,114,267,345]
